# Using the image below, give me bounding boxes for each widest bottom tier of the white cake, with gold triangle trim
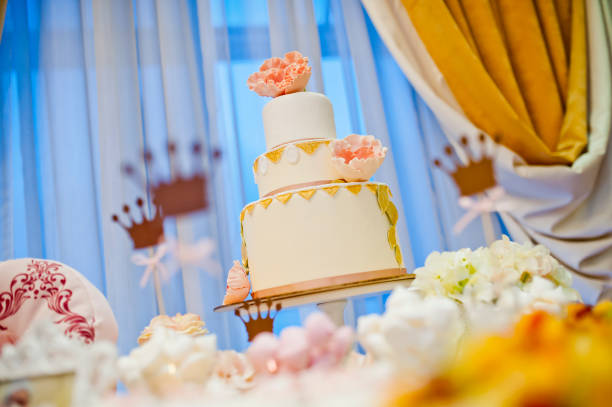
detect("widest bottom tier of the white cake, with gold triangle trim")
[240,182,406,298]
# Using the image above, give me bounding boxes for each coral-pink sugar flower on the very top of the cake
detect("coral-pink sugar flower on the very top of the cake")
[247,51,311,97]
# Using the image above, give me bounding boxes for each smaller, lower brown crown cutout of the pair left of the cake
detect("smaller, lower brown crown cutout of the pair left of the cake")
[112,198,164,249]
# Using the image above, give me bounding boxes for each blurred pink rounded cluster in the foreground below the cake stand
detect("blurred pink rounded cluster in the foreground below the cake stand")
[247,313,354,374]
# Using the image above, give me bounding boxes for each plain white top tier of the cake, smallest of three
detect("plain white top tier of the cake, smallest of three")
[263,92,336,150]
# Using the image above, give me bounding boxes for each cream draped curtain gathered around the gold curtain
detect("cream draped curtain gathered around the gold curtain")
[363,0,612,301]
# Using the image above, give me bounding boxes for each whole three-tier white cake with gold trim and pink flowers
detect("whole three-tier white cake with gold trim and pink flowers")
[240,52,405,298]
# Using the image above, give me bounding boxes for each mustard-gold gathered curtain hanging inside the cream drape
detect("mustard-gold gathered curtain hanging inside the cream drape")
[402,0,588,164]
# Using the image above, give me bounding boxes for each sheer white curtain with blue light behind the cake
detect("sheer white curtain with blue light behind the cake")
[0,0,501,352]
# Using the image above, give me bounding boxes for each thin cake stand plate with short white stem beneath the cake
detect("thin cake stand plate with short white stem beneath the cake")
[214,269,414,330]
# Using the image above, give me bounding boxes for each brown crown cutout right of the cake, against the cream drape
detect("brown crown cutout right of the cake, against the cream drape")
[434,134,497,196]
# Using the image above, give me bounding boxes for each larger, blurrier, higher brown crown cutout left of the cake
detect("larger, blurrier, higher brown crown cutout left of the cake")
[123,142,208,216]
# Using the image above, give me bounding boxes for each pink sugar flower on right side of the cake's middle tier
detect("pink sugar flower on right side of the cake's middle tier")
[330,134,387,182]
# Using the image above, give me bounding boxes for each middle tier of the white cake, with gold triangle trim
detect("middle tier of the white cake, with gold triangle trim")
[253,139,341,197]
